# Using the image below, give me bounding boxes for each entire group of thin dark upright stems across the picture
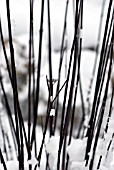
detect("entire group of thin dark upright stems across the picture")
[0,0,114,170]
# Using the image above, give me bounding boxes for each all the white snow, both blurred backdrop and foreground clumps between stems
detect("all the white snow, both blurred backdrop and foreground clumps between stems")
[0,0,114,170]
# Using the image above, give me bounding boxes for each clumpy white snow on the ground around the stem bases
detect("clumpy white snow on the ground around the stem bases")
[0,112,114,170]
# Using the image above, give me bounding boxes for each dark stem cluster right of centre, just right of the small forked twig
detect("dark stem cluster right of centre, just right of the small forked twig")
[57,1,83,170]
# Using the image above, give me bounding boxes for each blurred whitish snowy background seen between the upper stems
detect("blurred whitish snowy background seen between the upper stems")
[0,0,109,131]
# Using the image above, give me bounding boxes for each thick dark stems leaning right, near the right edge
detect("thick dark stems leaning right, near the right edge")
[85,0,112,166]
